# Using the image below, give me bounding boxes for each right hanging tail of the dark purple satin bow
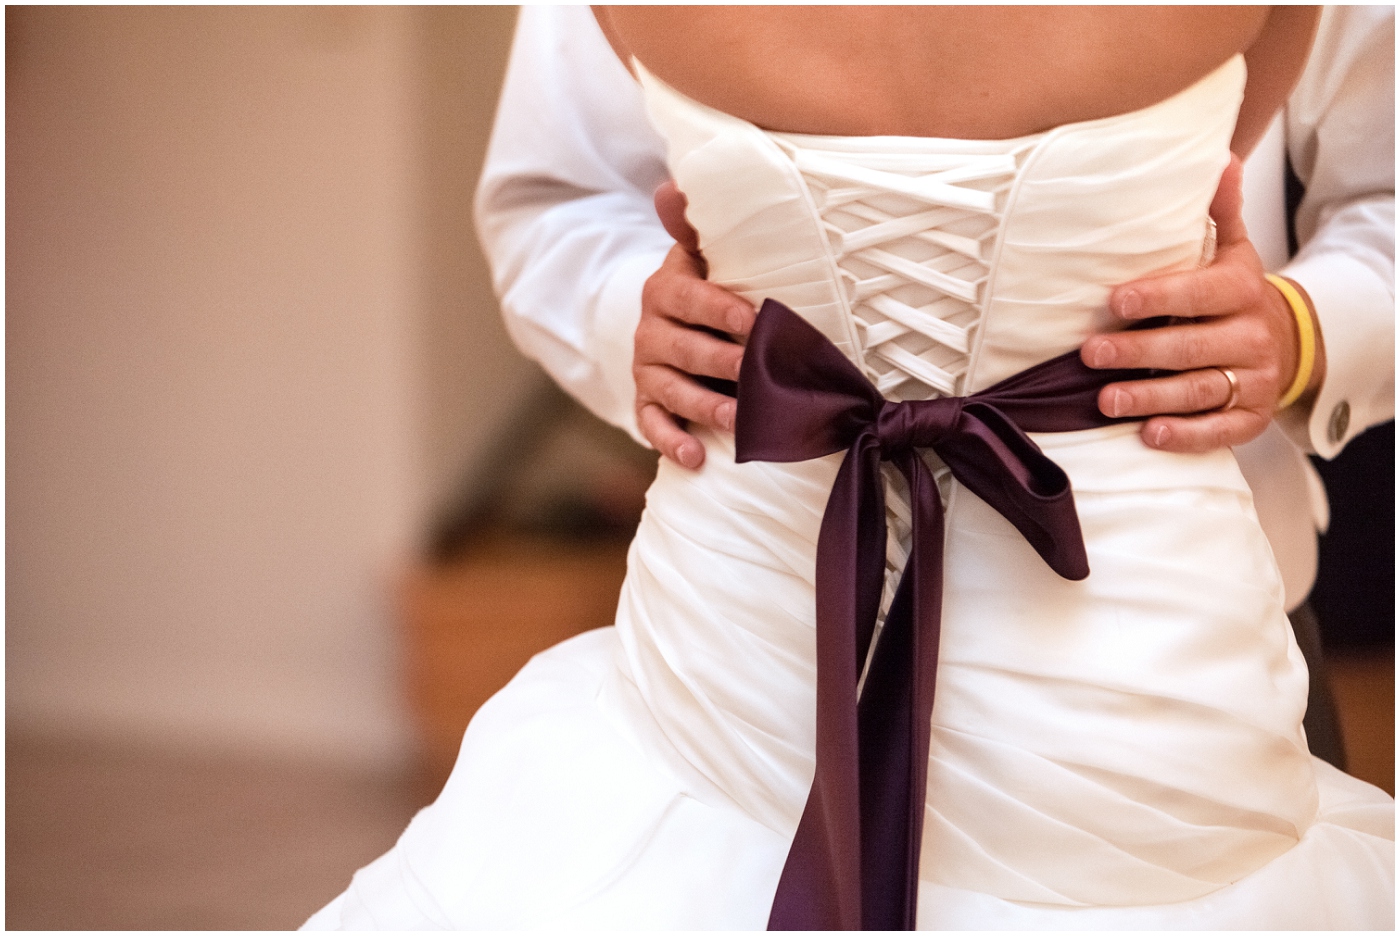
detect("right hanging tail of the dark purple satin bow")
[860,453,944,929]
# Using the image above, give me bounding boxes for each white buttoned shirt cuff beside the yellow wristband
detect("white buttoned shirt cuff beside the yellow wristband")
[1278,252,1394,459]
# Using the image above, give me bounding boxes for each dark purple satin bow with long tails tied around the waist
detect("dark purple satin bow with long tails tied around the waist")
[735,299,1144,929]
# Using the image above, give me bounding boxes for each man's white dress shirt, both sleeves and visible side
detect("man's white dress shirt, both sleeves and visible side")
[476,6,1394,607]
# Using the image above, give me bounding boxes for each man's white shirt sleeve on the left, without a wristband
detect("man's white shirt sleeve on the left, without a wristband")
[476,6,672,445]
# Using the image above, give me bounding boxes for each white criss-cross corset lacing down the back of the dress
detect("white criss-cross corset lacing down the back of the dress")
[774,134,1030,621]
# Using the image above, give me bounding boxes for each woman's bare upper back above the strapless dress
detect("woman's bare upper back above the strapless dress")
[598,6,1317,153]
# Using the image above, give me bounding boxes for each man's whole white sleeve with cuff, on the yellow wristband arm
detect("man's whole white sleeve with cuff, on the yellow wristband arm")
[1280,7,1394,458]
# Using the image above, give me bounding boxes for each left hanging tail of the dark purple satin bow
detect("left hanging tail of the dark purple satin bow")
[769,434,885,929]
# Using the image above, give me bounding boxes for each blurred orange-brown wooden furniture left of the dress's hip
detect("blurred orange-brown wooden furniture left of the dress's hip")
[399,536,627,790]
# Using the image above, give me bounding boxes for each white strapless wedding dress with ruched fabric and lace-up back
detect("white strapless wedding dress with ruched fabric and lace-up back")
[308,57,1394,929]
